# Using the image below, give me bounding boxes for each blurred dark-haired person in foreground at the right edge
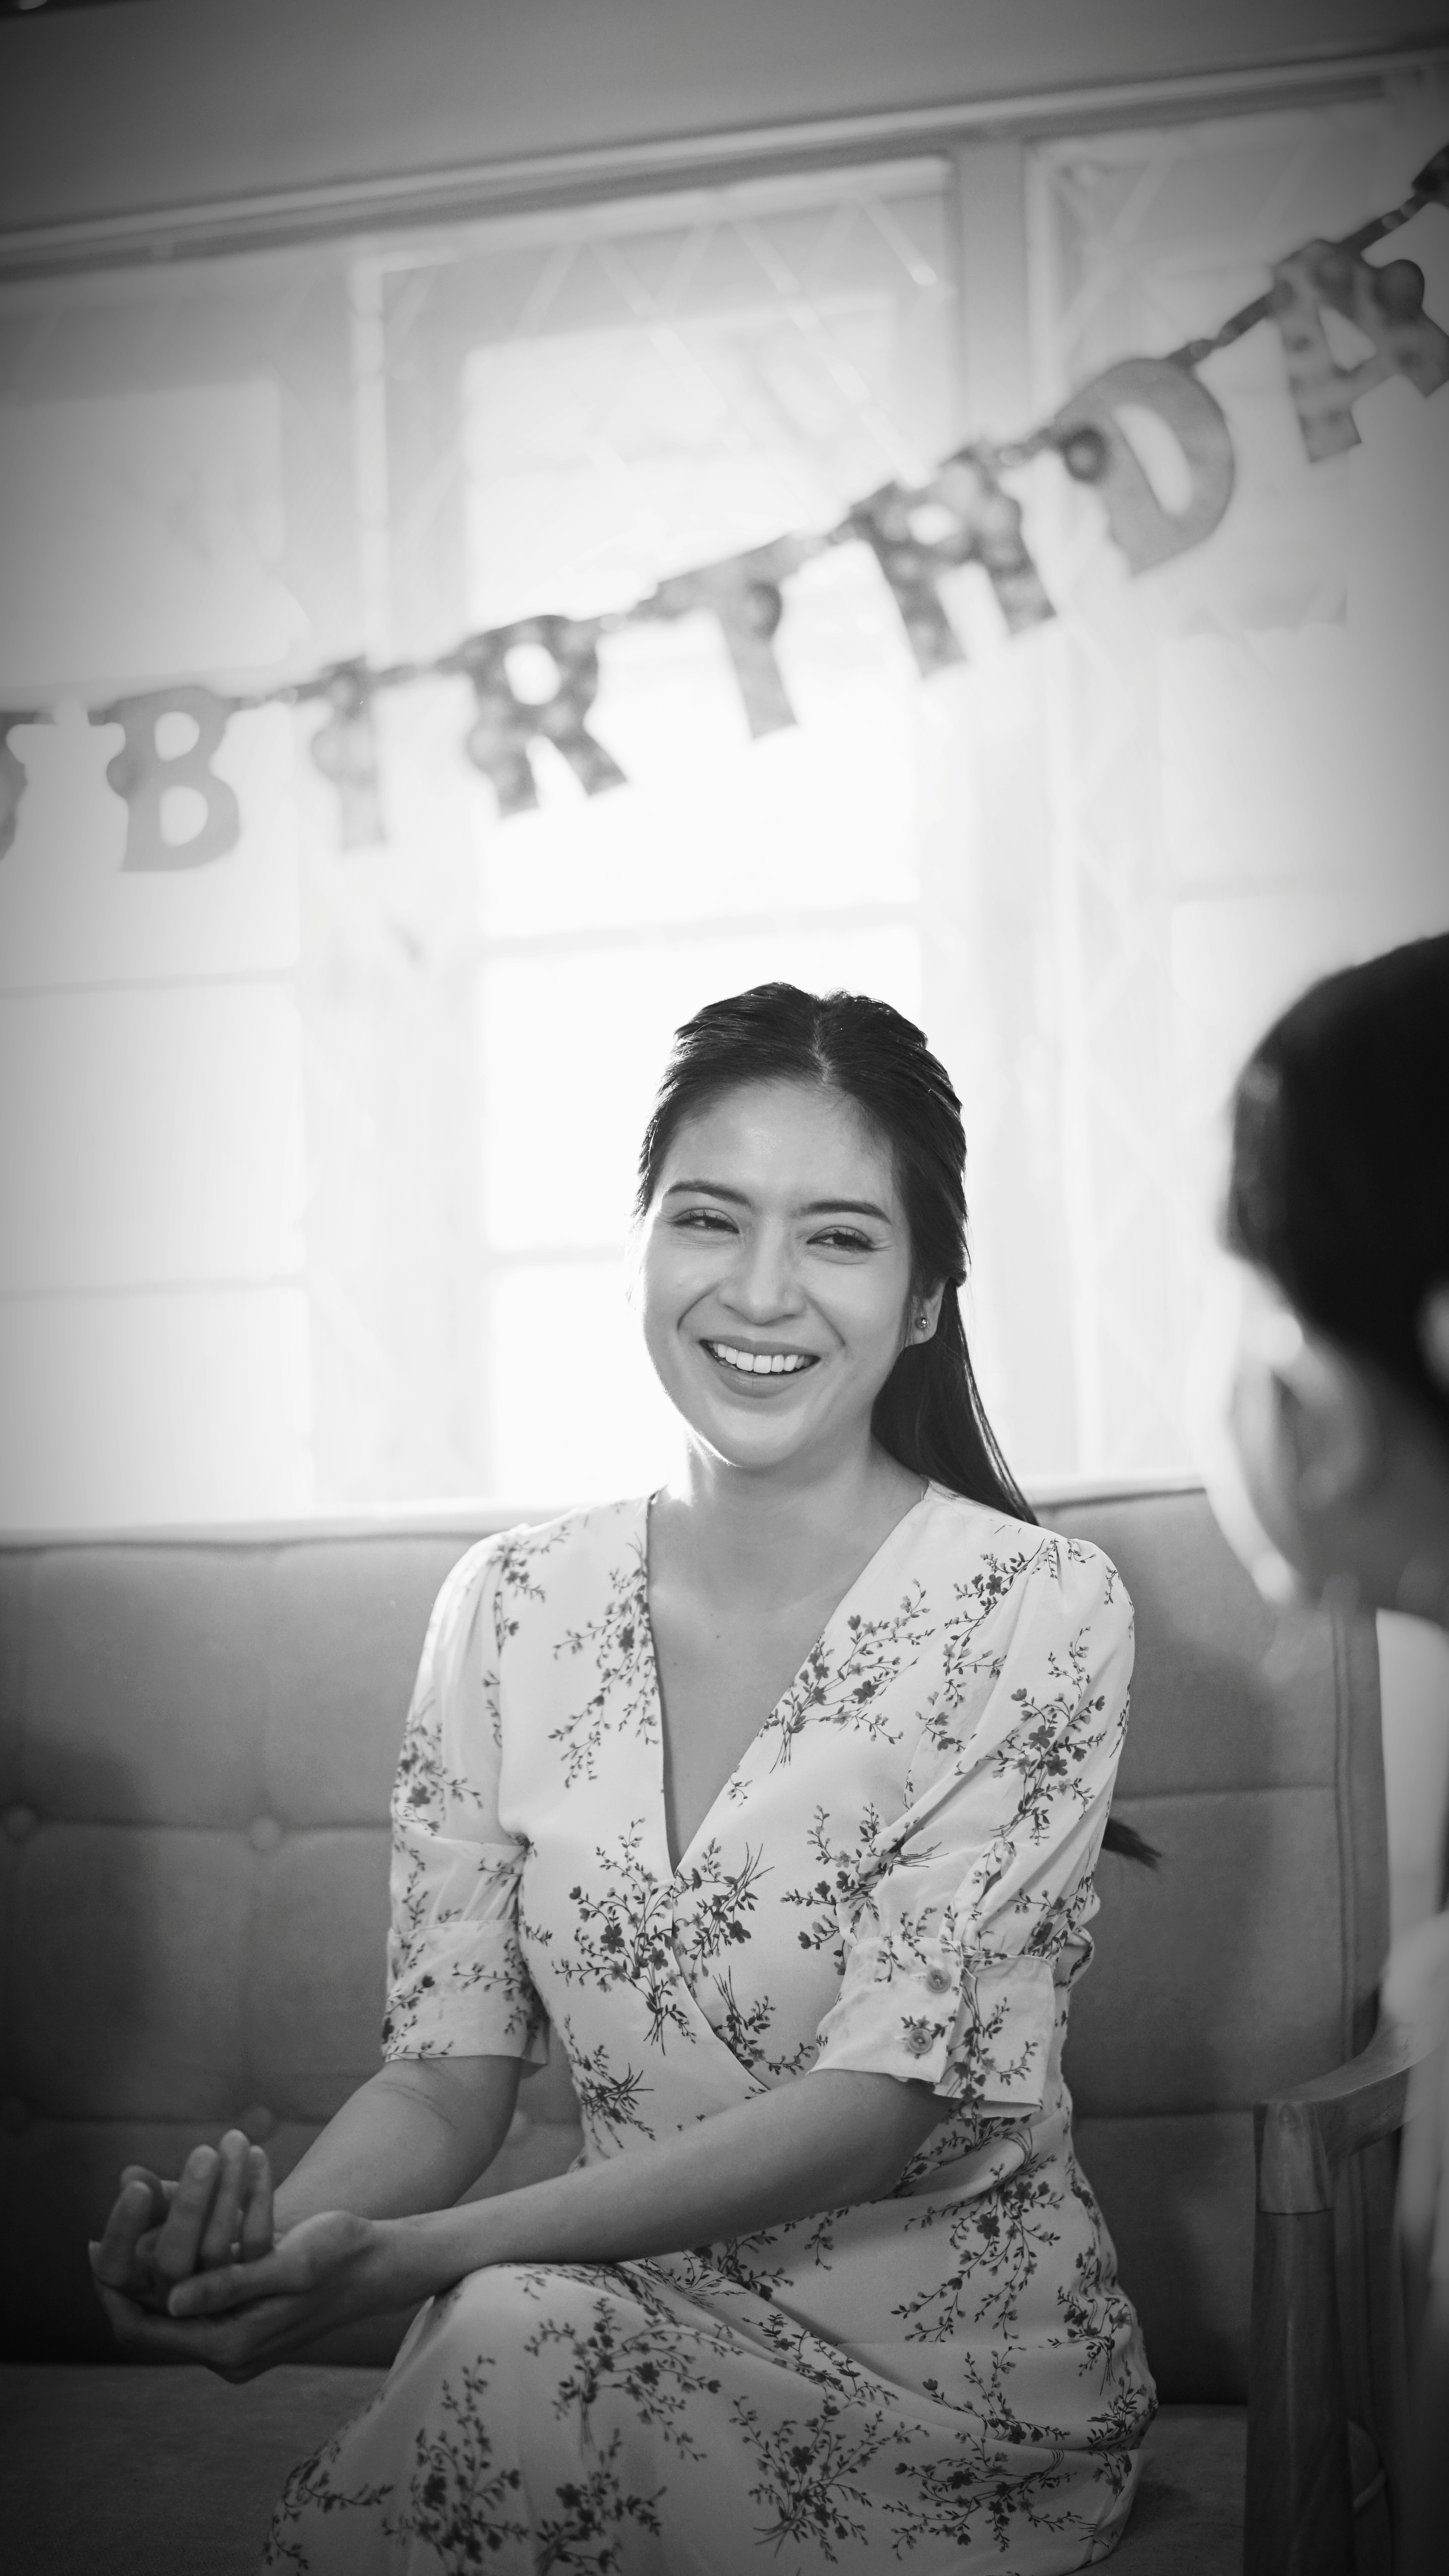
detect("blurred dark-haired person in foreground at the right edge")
[1209,935,1449,2576]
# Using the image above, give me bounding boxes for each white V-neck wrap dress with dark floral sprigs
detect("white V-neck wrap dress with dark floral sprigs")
[266,1486,1152,2576]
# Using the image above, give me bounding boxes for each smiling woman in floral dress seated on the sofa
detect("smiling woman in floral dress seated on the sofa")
[95,984,1152,2576]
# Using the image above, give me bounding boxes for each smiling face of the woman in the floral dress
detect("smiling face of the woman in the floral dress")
[642,1082,917,1471]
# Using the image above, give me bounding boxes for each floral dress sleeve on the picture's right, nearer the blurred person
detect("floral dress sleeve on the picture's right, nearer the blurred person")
[815,1535,1132,2112]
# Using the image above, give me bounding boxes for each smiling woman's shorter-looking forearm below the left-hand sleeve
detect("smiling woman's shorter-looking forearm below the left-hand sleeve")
[276,2058,518,2231]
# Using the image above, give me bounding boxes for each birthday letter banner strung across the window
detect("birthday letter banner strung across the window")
[0,144,1449,871]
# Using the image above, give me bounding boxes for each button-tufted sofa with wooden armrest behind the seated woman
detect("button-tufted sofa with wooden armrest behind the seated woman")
[0,1486,1387,2576]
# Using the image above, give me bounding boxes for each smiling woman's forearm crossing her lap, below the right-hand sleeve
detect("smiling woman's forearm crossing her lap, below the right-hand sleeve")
[389,2074,928,2290]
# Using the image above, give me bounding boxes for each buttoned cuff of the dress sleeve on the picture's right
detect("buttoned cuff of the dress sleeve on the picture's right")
[815,1935,1057,2110]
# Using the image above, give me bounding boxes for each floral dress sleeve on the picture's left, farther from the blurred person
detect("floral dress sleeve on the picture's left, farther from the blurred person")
[382,1540,547,2063]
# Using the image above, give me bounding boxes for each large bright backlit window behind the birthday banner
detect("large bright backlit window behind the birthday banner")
[0,88,1449,1525]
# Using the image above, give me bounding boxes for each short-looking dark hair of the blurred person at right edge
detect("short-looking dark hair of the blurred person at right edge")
[1225,935,1449,1437]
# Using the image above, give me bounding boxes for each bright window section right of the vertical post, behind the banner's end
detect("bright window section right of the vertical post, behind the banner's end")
[1011,82,1449,1471]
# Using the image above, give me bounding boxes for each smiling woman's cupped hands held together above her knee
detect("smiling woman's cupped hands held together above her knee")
[90,2128,412,2380]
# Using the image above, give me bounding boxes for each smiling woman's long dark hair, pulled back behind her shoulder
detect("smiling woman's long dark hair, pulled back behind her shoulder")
[637,984,1155,1860]
